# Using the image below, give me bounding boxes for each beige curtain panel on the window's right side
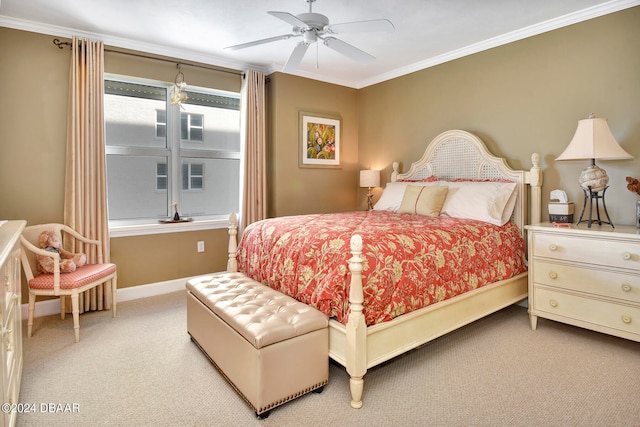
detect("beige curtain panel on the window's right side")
[240,70,267,228]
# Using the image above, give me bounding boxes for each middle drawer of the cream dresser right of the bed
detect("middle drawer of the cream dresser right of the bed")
[529,261,640,302]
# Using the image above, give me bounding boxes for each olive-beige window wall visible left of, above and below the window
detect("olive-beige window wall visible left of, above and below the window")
[0,28,241,300]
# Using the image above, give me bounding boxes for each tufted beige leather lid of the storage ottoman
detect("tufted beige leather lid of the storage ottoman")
[186,273,329,348]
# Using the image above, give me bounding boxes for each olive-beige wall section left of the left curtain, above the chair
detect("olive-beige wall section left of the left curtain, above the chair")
[0,28,69,224]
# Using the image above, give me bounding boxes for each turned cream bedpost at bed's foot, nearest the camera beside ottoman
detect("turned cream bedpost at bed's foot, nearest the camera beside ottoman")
[346,234,367,409]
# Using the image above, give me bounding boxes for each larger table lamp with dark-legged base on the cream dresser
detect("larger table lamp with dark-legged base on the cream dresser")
[556,114,633,228]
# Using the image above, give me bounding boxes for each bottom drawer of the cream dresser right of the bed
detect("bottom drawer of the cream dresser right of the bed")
[533,288,640,334]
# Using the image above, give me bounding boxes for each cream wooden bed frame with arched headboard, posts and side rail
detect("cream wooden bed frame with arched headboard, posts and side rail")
[227,130,542,408]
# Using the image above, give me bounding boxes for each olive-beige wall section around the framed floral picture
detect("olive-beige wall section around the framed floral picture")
[267,73,358,217]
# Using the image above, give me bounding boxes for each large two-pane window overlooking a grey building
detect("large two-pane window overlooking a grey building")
[105,76,240,225]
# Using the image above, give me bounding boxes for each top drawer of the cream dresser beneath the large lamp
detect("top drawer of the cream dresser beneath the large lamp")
[533,233,640,271]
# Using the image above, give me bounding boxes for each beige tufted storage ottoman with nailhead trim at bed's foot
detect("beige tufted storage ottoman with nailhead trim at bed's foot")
[186,273,329,418]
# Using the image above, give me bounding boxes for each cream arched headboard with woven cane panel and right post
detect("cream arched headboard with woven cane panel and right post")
[391,130,542,235]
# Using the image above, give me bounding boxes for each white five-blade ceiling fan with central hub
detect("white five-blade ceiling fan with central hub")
[225,0,395,72]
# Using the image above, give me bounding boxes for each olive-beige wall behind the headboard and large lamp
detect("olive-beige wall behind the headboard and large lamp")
[358,7,640,224]
